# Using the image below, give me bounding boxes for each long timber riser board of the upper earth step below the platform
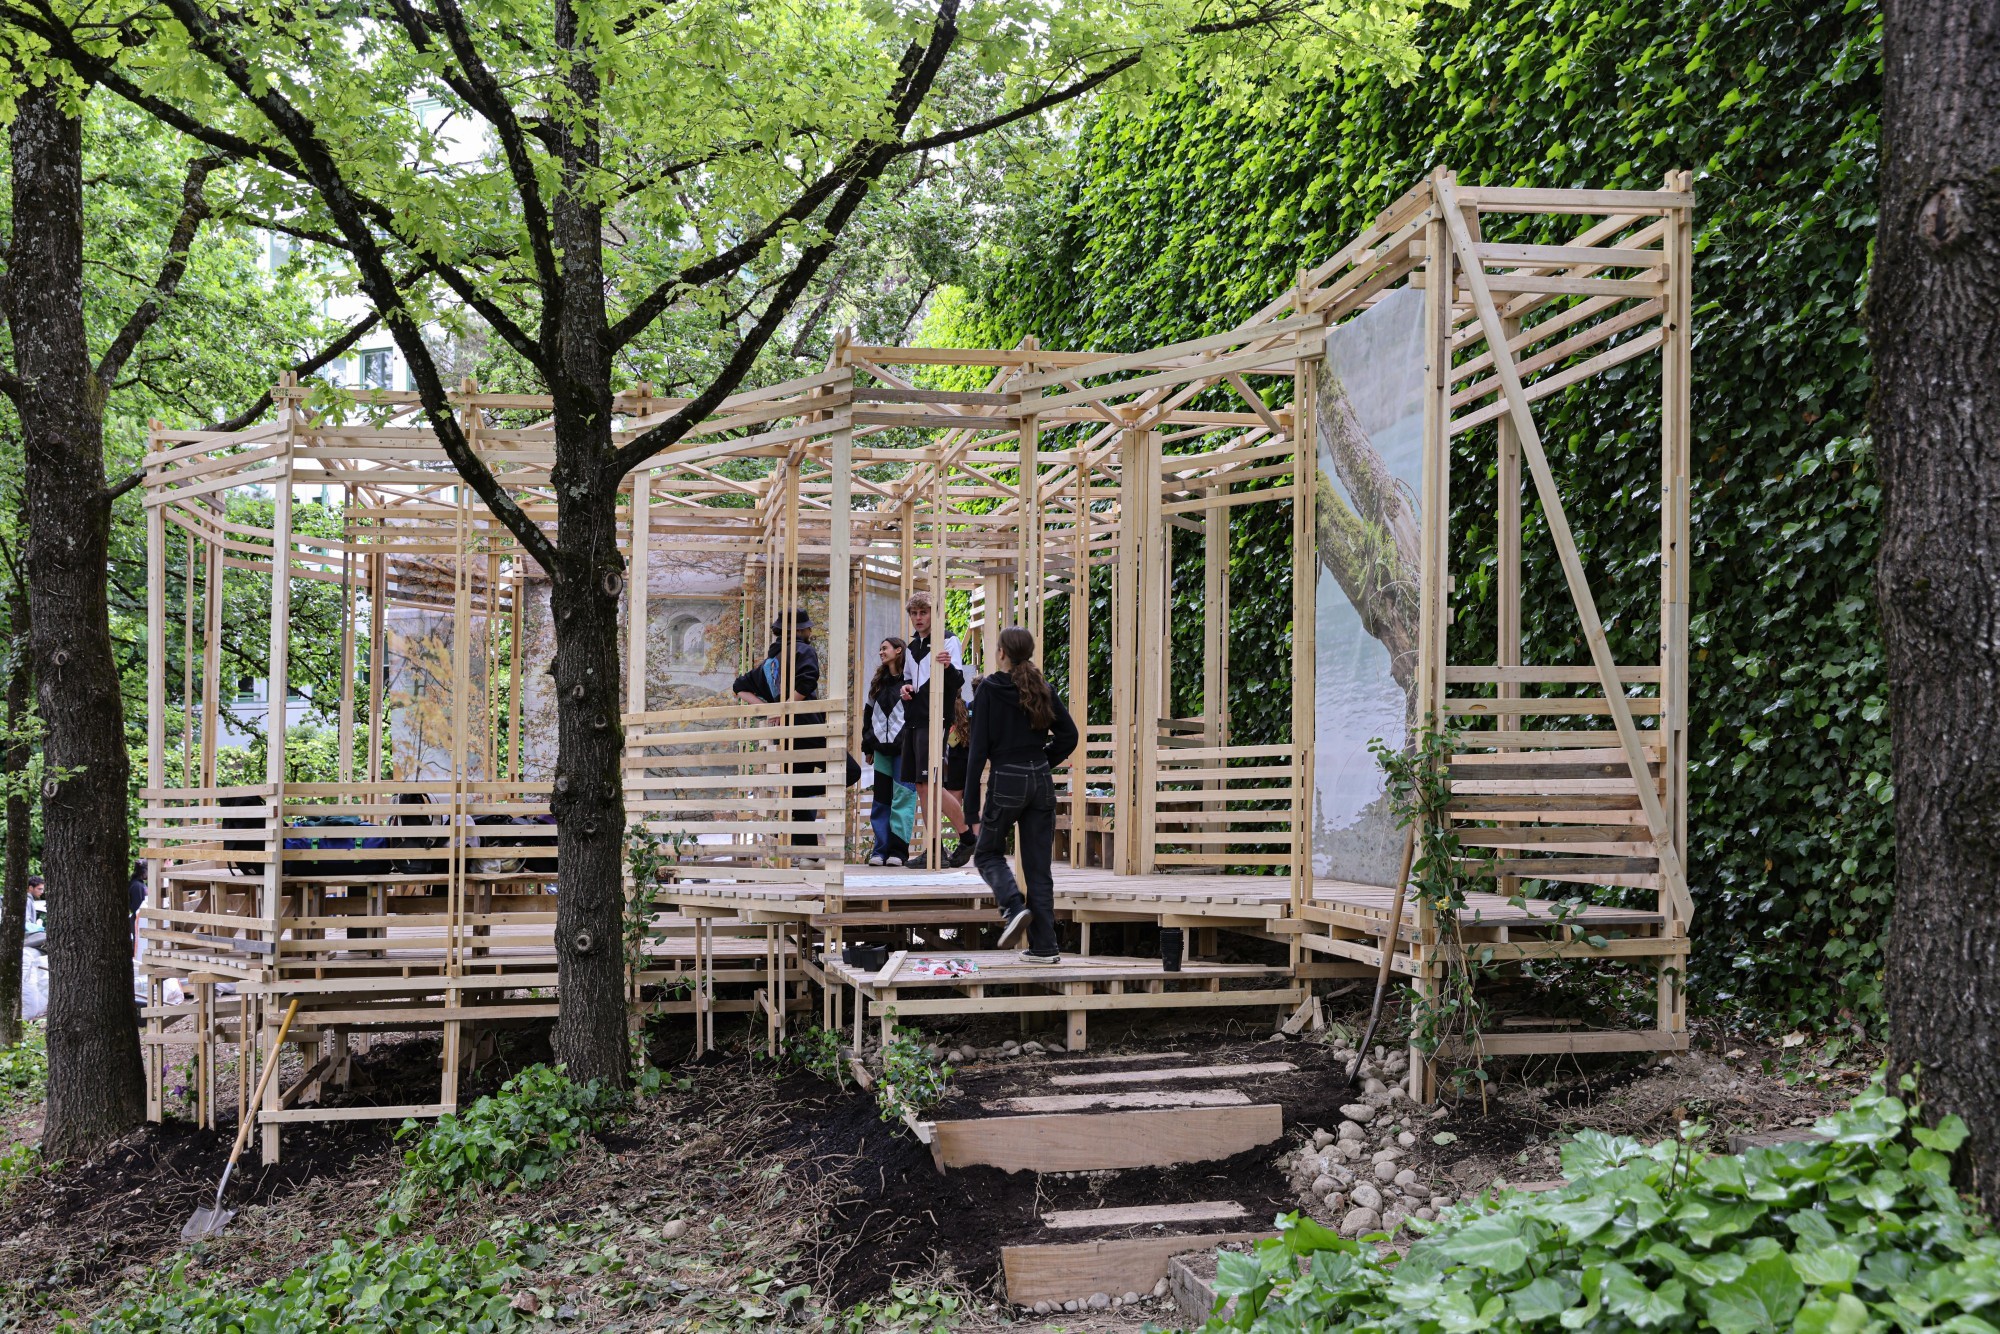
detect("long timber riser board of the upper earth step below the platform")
[936,1102,1284,1172]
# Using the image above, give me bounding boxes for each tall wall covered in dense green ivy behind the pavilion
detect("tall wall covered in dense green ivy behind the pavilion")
[934,0,1892,1024]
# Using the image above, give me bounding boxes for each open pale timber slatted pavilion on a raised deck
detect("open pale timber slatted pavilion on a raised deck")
[140,170,1692,1154]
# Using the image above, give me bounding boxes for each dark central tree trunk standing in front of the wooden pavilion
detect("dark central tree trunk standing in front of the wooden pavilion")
[548,0,630,1084]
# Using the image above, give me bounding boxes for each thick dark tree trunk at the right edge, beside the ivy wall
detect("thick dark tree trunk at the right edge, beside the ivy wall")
[1868,0,2000,1202]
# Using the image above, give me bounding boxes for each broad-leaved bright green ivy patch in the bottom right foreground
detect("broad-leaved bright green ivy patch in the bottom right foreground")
[1204,1078,2000,1334]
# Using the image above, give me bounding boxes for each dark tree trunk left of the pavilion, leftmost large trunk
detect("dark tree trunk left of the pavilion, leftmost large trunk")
[6,91,146,1158]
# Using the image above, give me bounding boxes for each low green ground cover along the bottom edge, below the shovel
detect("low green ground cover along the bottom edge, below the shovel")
[71,1238,534,1334]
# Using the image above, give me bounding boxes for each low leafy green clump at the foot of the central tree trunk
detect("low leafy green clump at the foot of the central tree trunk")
[396,1066,626,1200]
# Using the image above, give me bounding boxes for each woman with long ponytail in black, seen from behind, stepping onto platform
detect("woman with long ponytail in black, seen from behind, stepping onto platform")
[966,626,1076,964]
